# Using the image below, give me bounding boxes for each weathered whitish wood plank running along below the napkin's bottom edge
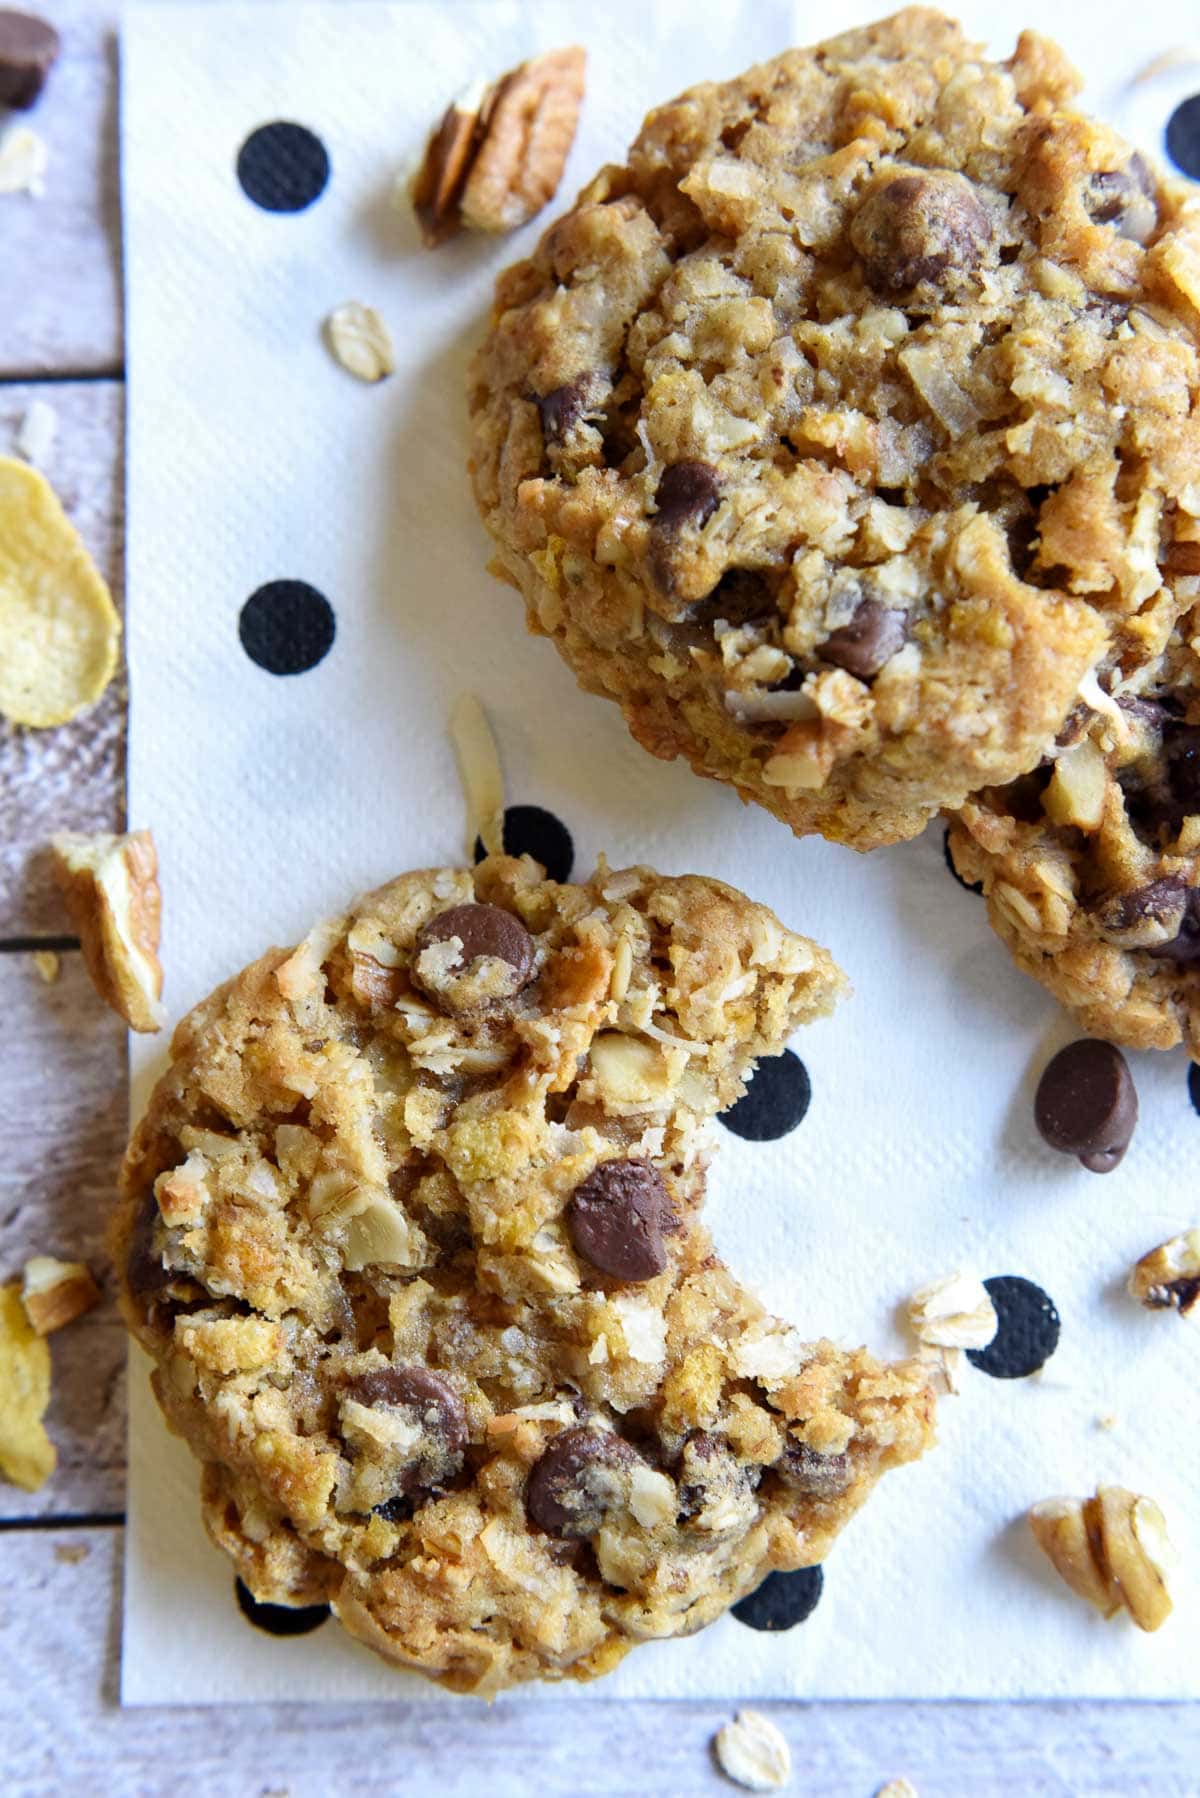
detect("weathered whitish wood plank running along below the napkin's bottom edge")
[0,1528,1200,1798]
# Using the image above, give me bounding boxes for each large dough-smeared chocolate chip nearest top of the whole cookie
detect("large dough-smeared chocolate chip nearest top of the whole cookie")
[849,174,991,293]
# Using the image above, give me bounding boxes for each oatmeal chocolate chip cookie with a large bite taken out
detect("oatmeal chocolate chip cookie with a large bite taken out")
[113,858,932,1694]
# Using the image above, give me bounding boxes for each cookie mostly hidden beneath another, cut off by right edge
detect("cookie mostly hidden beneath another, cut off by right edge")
[948,607,1200,1059]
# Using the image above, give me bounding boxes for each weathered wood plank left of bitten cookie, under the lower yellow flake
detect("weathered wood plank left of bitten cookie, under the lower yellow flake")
[0,953,128,1519]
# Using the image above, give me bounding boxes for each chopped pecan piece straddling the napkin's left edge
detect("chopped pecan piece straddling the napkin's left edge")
[52,831,164,1030]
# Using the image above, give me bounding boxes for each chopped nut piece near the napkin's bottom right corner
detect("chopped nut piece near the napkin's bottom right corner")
[1029,1485,1173,1631]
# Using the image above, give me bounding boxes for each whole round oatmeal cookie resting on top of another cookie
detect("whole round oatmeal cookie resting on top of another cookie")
[470,9,1200,849]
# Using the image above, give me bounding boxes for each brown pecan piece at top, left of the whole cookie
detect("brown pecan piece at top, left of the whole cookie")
[412,45,587,248]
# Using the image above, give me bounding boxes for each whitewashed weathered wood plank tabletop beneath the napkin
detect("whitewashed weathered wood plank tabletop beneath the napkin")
[0,0,1200,1798]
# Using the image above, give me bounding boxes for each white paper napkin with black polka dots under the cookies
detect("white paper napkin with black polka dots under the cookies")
[124,0,1200,1703]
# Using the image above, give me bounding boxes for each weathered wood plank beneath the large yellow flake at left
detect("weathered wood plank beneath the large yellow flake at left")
[0,381,126,940]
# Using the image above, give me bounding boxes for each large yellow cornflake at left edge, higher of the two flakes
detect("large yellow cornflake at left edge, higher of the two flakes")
[0,457,121,726]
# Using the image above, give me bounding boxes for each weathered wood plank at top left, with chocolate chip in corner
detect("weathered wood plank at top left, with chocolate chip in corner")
[0,0,122,376]
